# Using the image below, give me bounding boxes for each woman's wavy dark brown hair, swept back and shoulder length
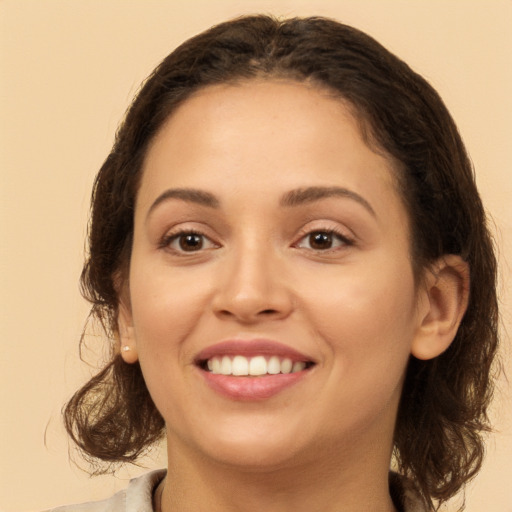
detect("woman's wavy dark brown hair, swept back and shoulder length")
[64,16,498,504]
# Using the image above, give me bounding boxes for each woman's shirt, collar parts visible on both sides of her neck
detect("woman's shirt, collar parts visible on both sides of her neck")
[47,469,428,512]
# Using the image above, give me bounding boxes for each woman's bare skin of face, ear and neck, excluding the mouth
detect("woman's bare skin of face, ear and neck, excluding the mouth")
[119,81,467,512]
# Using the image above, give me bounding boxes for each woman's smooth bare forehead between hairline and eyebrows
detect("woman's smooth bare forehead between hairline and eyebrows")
[137,80,406,224]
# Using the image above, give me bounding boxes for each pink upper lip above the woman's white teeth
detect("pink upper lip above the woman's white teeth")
[196,338,314,364]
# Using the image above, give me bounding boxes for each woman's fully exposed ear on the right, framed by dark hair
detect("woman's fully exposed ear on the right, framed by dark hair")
[411,254,470,360]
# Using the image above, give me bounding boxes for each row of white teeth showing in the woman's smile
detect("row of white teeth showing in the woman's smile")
[206,355,306,376]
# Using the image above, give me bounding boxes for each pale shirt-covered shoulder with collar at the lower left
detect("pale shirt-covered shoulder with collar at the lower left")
[46,469,165,512]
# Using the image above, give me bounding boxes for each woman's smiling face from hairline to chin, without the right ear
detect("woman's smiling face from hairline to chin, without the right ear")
[120,81,428,467]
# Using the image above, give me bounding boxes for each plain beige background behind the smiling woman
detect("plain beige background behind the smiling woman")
[0,0,512,512]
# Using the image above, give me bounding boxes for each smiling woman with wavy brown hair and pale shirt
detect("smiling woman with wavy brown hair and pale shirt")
[56,16,497,512]
